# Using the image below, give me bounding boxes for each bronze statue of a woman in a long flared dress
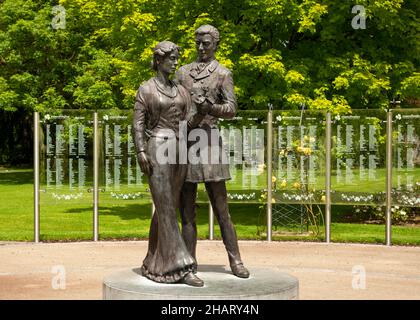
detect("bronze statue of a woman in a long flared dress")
[133,41,203,287]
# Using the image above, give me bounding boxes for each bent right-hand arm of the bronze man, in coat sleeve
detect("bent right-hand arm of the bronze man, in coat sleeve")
[209,72,237,119]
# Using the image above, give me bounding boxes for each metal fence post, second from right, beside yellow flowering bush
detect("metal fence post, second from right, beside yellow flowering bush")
[325,112,331,243]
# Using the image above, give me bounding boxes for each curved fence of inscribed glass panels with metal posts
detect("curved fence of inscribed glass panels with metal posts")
[34,106,420,245]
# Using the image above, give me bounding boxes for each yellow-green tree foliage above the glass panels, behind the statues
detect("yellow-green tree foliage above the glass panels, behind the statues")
[0,0,420,164]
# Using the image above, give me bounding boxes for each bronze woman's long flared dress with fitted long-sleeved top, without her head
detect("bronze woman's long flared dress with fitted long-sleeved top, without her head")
[133,79,196,283]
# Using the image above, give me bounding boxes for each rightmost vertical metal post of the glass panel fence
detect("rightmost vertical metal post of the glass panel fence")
[385,110,392,246]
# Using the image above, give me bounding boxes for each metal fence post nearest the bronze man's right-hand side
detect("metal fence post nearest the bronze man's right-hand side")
[267,103,273,241]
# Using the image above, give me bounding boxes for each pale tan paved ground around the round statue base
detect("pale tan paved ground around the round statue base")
[0,241,420,299]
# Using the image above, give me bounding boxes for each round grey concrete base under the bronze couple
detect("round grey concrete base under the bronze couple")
[103,266,299,300]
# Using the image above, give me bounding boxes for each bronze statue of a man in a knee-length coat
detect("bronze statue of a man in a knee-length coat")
[175,25,249,278]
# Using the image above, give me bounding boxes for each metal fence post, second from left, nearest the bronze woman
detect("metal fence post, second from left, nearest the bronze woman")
[93,112,99,241]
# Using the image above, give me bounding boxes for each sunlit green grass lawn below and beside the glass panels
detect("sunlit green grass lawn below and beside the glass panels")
[0,168,420,245]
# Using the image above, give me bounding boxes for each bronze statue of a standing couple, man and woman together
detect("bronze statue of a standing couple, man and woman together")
[133,25,249,287]
